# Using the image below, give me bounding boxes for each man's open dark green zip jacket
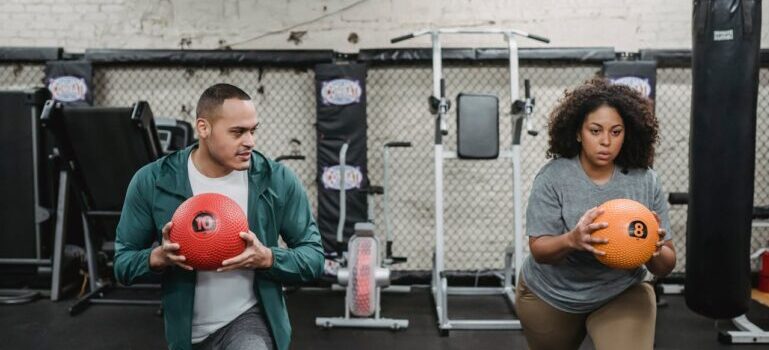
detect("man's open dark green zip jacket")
[114,144,323,349]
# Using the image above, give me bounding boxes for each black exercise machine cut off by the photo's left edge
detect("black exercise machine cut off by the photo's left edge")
[0,89,77,303]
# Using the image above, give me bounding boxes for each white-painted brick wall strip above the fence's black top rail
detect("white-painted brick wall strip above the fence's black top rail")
[0,0,769,52]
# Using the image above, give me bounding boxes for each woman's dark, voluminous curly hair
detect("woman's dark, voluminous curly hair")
[547,78,659,169]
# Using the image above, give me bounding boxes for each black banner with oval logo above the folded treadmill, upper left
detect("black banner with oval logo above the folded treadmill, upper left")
[45,61,93,105]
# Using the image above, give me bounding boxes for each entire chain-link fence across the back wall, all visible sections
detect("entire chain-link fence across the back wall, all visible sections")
[0,58,769,272]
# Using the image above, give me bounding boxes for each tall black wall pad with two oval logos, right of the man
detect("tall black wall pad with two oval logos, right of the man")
[315,64,368,252]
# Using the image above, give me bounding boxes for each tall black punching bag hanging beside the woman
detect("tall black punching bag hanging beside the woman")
[685,0,761,319]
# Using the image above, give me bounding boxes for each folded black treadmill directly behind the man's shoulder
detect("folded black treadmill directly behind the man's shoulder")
[41,100,162,315]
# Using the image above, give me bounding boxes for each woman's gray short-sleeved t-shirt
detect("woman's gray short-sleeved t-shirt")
[521,157,672,313]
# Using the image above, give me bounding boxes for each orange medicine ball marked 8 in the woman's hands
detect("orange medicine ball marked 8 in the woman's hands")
[593,199,659,269]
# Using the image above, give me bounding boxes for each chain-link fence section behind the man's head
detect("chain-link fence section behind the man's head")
[93,66,317,206]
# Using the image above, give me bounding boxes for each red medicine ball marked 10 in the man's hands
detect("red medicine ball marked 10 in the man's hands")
[170,193,248,270]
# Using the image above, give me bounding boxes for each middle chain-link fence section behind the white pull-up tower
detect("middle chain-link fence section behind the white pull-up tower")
[368,64,600,270]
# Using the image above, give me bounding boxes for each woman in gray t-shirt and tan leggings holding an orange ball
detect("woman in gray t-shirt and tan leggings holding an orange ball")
[516,79,676,350]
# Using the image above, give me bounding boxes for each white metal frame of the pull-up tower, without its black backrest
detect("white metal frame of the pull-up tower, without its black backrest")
[391,28,549,335]
